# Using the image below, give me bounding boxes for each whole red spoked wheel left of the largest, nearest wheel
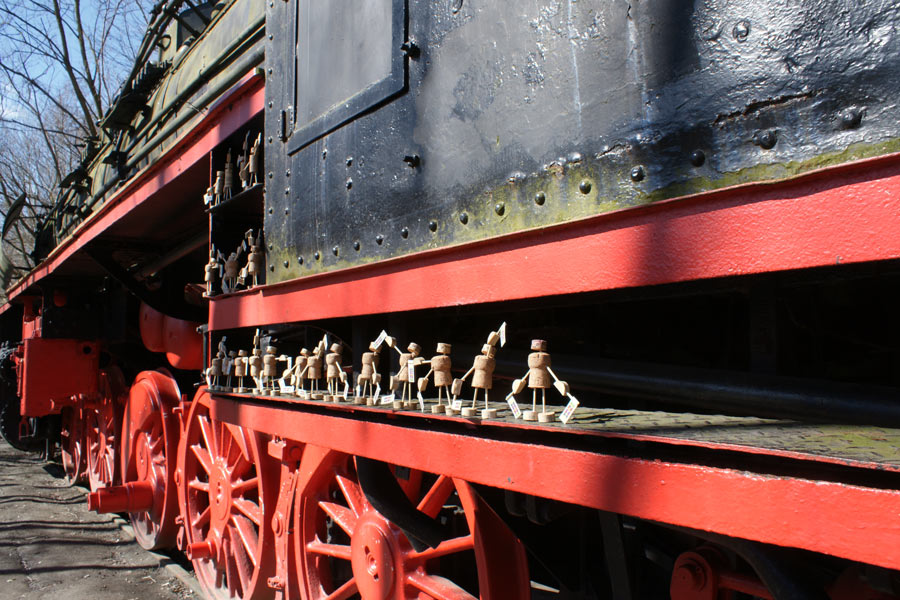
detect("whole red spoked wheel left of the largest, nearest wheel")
[178,388,279,600]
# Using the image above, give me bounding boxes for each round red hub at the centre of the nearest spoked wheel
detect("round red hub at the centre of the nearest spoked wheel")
[350,512,395,600]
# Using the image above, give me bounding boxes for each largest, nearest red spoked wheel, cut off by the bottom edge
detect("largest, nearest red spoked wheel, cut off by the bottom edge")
[294,445,530,600]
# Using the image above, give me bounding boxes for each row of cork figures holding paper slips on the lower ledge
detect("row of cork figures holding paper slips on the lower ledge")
[207,323,579,423]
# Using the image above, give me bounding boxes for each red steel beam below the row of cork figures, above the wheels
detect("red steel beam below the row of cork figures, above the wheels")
[211,398,900,569]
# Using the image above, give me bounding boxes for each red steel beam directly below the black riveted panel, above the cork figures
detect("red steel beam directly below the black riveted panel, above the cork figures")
[210,150,900,330]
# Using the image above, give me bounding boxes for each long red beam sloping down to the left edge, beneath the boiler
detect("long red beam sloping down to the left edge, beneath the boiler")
[0,74,265,304]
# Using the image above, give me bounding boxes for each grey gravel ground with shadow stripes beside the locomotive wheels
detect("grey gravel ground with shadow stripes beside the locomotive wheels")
[0,440,197,600]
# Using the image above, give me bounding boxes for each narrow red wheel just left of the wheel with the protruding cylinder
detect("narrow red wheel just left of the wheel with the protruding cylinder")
[84,367,127,492]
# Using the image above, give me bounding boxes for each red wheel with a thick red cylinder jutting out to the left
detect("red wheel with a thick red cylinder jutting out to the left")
[120,371,181,550]
